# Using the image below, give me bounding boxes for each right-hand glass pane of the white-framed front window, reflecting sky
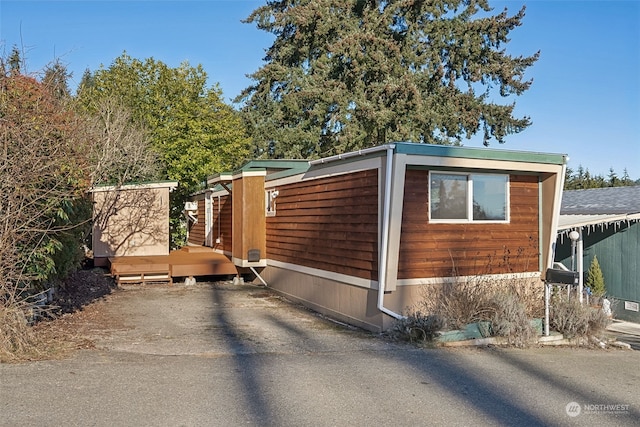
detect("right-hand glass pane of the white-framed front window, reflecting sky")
[471,175,508,221]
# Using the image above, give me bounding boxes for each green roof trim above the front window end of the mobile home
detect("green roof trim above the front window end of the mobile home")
[393,142,567,165]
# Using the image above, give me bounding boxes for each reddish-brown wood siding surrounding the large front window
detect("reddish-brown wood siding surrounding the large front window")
[398,170,539,279]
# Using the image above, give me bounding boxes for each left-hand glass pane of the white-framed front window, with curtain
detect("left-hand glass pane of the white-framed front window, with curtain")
[430,173,468,219]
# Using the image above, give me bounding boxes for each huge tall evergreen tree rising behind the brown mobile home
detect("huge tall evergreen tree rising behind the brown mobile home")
[236,0,538,158]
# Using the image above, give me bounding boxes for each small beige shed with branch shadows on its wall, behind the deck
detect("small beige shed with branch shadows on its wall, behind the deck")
[90,181,178,266]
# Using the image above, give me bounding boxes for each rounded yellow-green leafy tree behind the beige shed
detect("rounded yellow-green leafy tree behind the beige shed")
[78,53,249,245]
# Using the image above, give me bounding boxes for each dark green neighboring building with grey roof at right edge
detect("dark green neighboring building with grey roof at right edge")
[555,186,640,322]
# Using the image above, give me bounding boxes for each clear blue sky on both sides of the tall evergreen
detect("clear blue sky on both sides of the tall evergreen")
[0,0,640,179]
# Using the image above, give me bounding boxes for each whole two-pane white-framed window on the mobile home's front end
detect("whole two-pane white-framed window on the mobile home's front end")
[429,172,509,222]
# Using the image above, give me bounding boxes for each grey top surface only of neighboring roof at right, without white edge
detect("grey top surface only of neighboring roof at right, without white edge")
[560,185,640,215]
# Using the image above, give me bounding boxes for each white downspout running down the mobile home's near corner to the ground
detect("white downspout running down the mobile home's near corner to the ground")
[378,145,405,319]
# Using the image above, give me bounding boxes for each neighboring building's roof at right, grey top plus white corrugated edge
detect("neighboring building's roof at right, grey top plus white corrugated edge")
[558,186,640,231]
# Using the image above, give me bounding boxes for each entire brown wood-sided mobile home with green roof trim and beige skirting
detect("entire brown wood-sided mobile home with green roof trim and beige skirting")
[189,142,566,331]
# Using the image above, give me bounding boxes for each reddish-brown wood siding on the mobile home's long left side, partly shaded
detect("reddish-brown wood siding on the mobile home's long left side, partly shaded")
[267,170,378,279]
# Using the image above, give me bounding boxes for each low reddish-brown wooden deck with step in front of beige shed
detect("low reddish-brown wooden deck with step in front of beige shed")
[109,246,238,284]
